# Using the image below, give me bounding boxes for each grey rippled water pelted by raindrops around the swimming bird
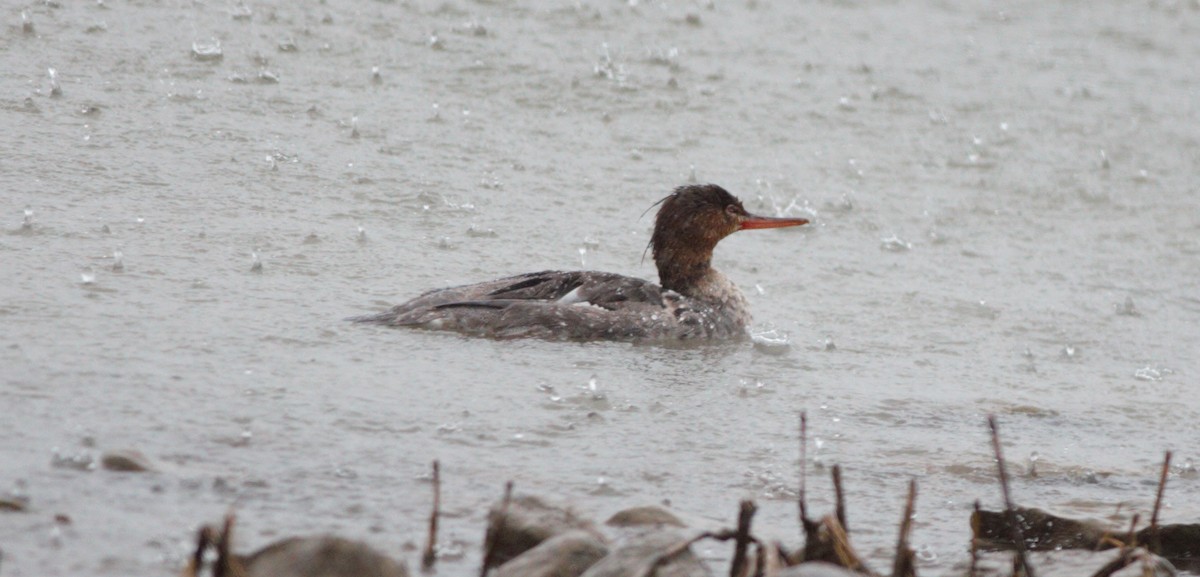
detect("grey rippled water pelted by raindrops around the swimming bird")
[0,0,1200,576]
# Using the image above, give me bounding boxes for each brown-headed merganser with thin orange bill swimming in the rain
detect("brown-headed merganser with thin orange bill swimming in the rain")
[350,185,809,341]
